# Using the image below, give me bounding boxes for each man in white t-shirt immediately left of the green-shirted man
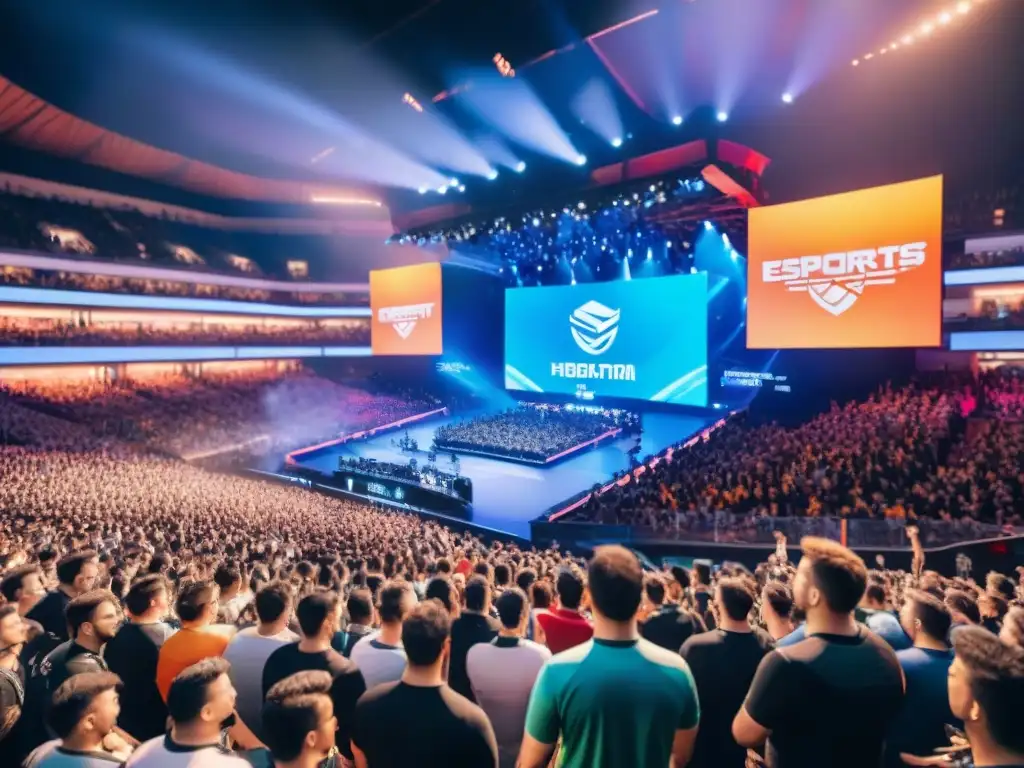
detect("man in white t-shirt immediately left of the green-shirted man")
[466,587,551,768]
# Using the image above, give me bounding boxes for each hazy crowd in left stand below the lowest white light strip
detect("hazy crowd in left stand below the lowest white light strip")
[0,371,436,459]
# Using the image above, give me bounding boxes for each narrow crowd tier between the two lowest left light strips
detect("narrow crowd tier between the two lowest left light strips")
[0,317,370,346]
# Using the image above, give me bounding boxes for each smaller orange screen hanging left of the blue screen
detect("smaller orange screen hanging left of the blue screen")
[370,262,442,354]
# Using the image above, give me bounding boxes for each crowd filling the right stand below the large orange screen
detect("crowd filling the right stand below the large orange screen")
[575,379,1024,532]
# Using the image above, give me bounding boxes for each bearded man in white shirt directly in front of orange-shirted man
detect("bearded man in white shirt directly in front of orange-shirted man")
[128,656,250,768]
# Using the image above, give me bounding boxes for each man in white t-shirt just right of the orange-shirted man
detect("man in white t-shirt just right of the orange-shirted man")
[224,582,299,741]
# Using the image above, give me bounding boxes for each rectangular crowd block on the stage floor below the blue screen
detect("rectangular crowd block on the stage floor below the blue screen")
[434,406,638,462]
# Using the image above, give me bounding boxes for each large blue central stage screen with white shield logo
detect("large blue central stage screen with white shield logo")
[505,272,708,407]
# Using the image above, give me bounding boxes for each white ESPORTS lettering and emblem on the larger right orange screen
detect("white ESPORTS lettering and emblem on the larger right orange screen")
[761,243,928,316]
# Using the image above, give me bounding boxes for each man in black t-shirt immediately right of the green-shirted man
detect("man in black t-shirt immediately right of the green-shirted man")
[679,579,772,768]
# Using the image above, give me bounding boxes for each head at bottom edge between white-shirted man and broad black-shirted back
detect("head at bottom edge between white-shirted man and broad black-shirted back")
[261,670,334,762]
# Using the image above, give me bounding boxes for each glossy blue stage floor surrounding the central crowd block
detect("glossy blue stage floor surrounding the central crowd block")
[292,412,722,539]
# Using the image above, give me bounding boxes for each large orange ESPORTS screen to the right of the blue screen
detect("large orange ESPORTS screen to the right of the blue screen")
[746,176,942,349]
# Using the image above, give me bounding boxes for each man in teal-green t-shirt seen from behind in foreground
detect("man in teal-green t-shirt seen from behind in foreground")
[519,547,700,768]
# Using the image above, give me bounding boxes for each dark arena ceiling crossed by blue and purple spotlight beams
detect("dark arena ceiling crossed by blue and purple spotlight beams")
[0,0,1019,208]
